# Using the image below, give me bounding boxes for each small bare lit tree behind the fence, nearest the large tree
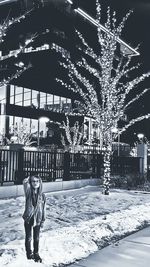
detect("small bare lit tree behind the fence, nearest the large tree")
[61,116,83,152]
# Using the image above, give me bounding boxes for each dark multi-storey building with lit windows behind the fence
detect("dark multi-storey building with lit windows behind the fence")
[0,0,138,148]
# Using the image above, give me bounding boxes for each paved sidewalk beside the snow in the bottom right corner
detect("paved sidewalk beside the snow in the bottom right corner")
[69,227,150,267]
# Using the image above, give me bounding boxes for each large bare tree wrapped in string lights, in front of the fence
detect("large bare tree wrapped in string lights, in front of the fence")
[56,0,150,197]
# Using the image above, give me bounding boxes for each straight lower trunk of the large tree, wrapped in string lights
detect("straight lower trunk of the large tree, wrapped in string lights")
[103,146,111,195]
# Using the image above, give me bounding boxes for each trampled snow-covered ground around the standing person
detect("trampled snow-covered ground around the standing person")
[0,186,150,267]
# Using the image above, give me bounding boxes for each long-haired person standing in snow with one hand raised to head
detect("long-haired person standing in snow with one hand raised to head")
[23,175,46,262]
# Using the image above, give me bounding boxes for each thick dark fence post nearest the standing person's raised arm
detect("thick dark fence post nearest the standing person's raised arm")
[15,148,25,184]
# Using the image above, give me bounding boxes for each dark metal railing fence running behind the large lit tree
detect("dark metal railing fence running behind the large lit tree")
[0,149,139,185]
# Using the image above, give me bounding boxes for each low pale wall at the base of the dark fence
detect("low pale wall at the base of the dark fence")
[0,179,100,199]
